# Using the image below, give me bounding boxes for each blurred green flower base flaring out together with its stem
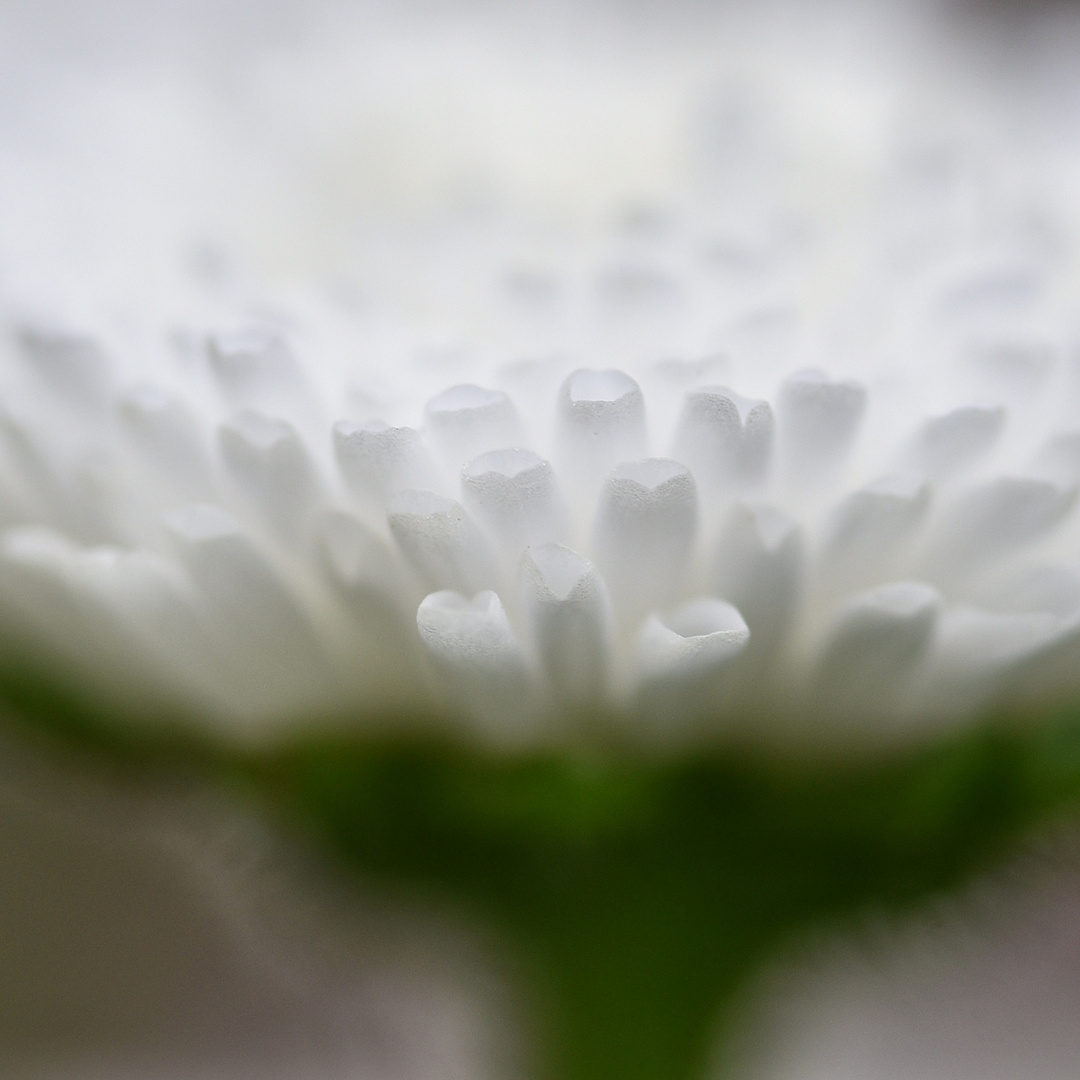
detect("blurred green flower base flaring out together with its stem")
[243,732,1080,1080]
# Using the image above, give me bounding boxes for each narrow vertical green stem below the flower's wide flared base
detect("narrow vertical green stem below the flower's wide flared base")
[505,853,762,1080]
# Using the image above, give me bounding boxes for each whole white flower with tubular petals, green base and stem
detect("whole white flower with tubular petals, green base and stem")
[6,3,1080,1080]
